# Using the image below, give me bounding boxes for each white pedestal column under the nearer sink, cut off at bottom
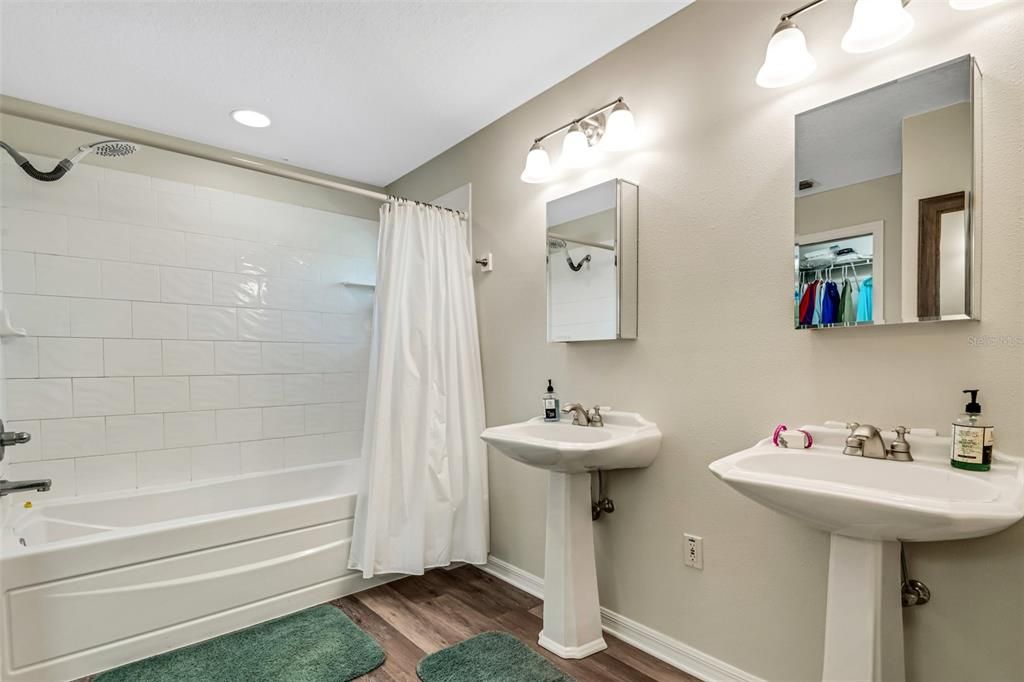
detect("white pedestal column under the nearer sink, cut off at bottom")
[821,534,906,682]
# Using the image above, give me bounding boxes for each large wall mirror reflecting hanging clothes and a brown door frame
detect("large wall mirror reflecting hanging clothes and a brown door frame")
[794,55,981,329]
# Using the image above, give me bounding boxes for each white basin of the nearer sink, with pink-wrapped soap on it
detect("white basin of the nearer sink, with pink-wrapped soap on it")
[711,427,1024,541]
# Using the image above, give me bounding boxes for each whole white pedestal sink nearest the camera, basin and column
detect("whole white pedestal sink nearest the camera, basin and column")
[710,426,1024,682]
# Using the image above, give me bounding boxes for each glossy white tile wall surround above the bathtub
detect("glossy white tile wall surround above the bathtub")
[0,159,377,497]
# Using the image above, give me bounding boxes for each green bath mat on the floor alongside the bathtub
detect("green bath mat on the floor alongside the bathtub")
[93,605,384,682]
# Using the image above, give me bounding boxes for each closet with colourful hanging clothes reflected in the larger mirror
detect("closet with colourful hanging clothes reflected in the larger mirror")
[794,221,883,329]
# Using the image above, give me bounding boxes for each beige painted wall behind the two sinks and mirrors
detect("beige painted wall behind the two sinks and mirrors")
[391,0,1024,681]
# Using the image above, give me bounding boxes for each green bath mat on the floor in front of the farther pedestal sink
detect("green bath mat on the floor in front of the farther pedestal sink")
[416,632,575,682]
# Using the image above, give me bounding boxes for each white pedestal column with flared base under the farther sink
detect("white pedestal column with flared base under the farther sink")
[538,471,607,658]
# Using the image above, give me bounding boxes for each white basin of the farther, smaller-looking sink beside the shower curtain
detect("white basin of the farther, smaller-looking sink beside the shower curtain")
[480,412,662,473]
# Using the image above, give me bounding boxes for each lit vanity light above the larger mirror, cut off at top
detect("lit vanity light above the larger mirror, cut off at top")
[756,0,917,88]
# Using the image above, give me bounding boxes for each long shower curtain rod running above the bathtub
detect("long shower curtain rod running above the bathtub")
[3,99,466,218]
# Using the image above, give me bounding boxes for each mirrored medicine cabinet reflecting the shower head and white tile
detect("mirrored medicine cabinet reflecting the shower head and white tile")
[547,179,640,342]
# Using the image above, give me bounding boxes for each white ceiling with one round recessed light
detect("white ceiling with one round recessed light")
[0,0,689,185]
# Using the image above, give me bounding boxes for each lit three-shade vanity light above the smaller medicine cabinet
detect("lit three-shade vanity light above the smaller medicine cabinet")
[519,96,634,182]
